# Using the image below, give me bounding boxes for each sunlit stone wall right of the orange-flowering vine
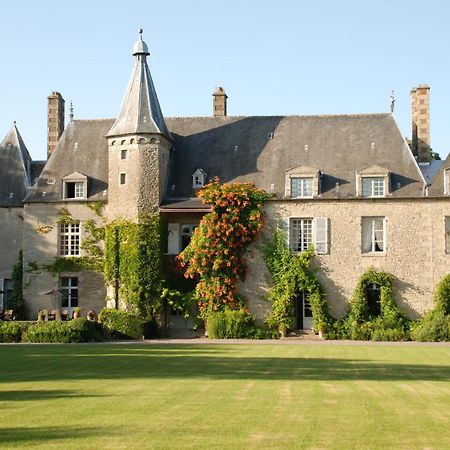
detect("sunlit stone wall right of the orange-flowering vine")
[241,198,450,318]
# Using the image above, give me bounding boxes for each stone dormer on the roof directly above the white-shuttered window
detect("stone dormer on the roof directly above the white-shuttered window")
[284,165,321,198]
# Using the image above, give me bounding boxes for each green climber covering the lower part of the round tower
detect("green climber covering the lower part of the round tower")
[104,216,163,319]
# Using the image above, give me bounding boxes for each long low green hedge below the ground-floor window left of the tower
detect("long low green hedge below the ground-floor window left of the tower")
[22,319,102,343]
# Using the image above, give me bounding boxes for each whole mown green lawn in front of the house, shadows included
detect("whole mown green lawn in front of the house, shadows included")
[0,344,450,450]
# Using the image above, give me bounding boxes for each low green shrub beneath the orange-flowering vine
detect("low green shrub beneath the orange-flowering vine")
[206,309,269,339]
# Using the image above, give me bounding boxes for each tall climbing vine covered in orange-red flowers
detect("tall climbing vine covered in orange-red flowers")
[178,179,270,318]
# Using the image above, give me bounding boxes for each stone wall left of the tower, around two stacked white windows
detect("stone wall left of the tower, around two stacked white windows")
[23,202,106,319]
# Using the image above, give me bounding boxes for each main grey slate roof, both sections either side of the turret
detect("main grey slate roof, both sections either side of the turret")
[23,114,424,204]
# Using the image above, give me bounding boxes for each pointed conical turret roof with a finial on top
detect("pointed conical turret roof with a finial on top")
[107,30,172,139]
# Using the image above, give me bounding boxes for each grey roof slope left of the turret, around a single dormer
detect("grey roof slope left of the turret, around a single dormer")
[25,119,114,202]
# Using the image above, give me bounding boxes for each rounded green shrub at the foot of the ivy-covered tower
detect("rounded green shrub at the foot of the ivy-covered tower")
[99,308,145,339]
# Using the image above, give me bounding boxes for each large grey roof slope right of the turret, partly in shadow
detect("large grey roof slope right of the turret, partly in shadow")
[167,114,423,198]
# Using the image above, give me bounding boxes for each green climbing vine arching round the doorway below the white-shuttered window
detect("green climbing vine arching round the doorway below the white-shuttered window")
[264,230,330,333]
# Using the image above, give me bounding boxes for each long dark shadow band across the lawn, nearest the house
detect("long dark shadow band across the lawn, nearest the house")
[0,345,450,383]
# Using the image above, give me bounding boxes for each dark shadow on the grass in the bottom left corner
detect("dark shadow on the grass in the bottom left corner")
[0,427,105,445]
